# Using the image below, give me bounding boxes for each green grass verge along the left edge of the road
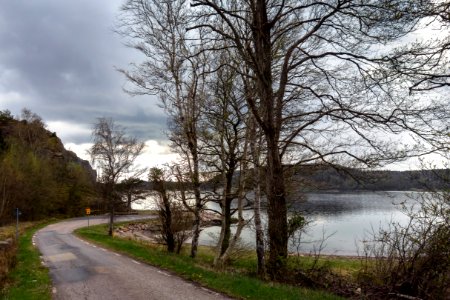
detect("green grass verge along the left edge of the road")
[0,222,51,300]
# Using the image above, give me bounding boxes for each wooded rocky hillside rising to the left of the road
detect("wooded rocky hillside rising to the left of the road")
[0,110,96,226]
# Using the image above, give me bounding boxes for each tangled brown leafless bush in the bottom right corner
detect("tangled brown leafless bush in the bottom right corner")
[359,184,450,299]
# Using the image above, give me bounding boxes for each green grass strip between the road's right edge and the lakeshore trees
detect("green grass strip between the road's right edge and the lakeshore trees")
[76,225,342,300]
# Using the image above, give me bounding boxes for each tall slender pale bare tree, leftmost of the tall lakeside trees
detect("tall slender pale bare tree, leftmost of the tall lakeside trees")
[118,0,207,257]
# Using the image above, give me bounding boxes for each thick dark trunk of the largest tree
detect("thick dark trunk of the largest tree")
[252,0,288,279]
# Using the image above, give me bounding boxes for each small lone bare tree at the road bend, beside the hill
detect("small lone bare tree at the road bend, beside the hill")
[89,118,144,236]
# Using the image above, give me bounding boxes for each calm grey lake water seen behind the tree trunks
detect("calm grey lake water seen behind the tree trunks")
[133,192,418,255]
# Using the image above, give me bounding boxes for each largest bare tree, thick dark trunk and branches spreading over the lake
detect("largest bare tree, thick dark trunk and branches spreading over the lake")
[190,0,448,277]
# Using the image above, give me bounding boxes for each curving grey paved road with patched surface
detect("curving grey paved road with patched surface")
[33,216,230,300]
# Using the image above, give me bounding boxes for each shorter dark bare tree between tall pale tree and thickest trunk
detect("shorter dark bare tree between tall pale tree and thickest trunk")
[199,51,249,267]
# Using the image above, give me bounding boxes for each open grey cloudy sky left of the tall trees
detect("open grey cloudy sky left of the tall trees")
[0,0,176,164]
